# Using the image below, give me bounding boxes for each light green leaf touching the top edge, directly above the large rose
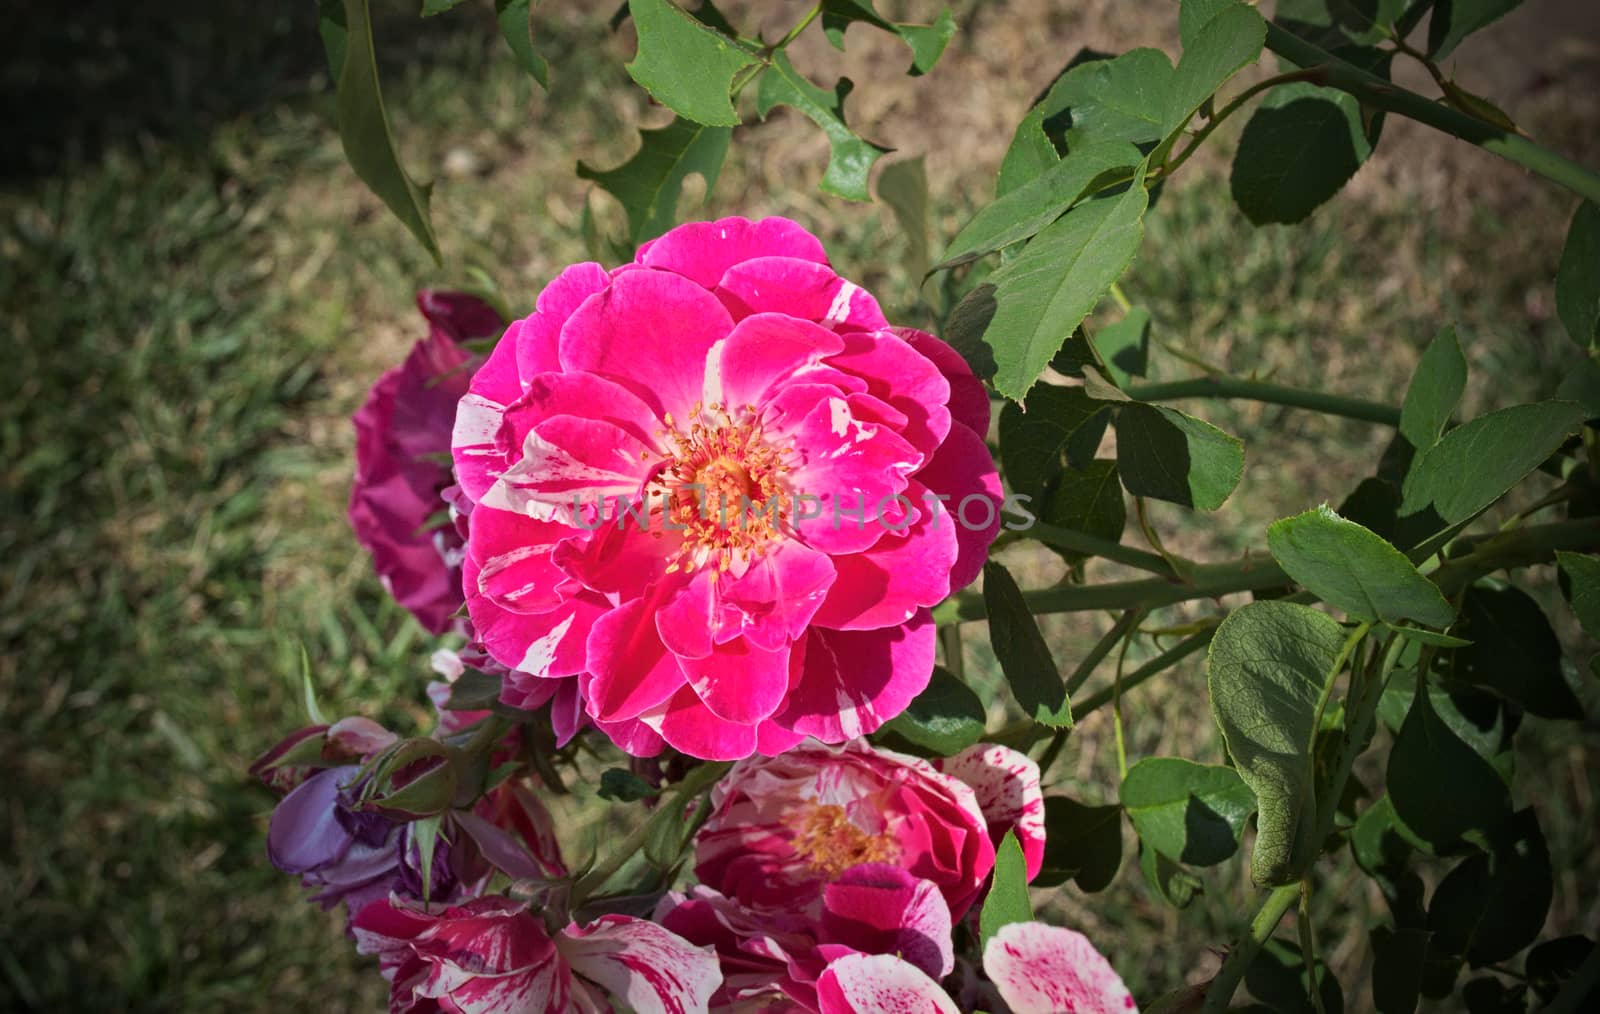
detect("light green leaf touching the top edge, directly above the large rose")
[627,0,760,126]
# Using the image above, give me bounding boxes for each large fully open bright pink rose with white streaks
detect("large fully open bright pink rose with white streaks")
[453,219,1000,760]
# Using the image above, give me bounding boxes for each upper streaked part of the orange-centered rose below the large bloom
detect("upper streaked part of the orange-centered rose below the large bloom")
[694,742,1045,920]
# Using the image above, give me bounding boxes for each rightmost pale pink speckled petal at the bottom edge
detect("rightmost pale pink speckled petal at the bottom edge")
[984,923,1138,1014]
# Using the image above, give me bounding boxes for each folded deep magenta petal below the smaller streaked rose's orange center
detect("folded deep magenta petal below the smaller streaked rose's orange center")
[822,864,955,979]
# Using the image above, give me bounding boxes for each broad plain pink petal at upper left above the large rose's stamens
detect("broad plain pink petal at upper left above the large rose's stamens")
[562,270,733,421]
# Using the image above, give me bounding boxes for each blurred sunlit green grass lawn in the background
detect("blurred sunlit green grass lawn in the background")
[0,8,1597,1011]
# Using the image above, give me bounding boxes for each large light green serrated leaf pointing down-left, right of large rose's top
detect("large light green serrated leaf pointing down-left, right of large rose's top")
[968,176,1149,400]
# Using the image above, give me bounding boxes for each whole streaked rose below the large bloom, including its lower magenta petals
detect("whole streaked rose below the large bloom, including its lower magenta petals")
[658,742,1045,1011]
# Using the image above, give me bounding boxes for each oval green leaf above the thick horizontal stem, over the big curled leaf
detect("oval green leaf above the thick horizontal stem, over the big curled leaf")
[1267,504,1456,627]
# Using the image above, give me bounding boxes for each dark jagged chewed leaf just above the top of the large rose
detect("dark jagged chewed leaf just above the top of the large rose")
[578,117,733,246]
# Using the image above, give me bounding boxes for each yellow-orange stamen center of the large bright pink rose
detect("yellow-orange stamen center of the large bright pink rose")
[653,403,794,577]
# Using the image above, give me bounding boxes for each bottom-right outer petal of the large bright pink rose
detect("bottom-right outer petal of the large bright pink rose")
[773,609,934,744]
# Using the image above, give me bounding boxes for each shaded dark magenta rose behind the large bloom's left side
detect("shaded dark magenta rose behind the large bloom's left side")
[350,289,504,633]
